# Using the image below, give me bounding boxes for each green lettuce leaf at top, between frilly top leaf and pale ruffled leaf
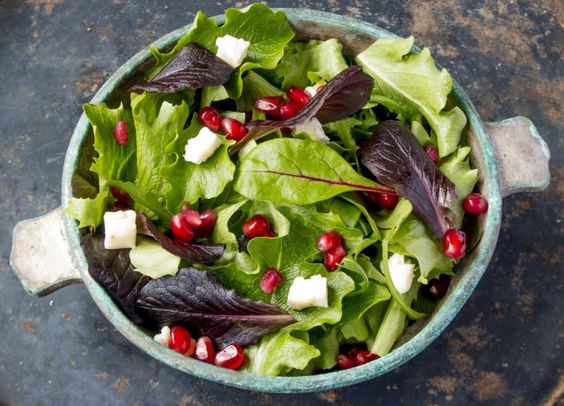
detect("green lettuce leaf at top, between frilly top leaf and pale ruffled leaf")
[274,38,347,89]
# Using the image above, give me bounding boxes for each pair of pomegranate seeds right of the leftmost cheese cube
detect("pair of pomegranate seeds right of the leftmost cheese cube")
[170,207,217,244]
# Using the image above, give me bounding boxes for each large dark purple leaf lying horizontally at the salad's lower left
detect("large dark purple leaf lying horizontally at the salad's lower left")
[137,268,295,348]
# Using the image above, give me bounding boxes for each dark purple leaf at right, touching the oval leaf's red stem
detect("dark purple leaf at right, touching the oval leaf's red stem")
[360,120,456,238]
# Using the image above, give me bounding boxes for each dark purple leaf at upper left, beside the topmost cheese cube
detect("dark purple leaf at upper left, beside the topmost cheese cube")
[131,44,233,93]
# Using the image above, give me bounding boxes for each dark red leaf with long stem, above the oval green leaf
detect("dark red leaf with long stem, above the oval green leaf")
[230,66,374,153]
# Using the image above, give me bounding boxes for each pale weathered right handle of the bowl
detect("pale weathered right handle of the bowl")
[484,116,550,197]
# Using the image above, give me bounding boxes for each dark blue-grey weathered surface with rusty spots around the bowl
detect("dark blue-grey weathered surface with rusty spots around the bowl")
[0,0,564,406]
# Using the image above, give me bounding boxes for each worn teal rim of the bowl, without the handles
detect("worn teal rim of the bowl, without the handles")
[61,8,501,393]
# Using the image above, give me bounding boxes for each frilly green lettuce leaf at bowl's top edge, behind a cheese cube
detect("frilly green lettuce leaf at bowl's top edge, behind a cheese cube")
[148,3,294,99]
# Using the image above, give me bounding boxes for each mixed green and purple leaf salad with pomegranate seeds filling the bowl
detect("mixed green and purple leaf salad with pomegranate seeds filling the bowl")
[66,4,484,375]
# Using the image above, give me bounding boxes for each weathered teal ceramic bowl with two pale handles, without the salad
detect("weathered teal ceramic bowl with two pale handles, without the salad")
[11,9,549,392]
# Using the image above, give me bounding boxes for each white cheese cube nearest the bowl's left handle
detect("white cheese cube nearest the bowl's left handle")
[104,210,137,250]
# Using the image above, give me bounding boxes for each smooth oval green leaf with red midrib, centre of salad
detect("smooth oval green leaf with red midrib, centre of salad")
[233,139,389,205]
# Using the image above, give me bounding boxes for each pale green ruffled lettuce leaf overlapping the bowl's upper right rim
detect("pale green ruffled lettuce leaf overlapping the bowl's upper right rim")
[356,37,466,157]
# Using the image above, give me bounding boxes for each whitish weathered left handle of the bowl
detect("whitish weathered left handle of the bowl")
[10,207,82,296]
